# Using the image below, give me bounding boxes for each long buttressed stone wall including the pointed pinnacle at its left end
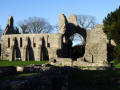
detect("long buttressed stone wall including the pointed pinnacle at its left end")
[1,17,62,61]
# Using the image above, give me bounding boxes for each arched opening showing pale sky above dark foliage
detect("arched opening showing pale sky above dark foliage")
[66,33,85,59]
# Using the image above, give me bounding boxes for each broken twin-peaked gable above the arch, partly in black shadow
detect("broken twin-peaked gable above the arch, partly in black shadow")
[59,14,86,41]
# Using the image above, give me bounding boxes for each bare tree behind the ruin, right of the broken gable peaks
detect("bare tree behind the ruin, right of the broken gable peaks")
[77,15,96,30]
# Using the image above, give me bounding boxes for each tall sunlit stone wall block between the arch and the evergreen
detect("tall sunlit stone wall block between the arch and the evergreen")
[84,25,107,63]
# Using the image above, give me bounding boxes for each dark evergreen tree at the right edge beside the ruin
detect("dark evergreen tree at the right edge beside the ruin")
[103,7,120,62]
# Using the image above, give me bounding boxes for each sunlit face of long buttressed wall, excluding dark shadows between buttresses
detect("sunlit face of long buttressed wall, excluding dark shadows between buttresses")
[1,34,61,61]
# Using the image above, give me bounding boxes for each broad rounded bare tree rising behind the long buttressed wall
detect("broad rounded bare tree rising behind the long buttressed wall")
[19,17,52,33]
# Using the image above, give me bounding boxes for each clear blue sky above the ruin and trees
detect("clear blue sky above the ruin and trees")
[0,0,120,29]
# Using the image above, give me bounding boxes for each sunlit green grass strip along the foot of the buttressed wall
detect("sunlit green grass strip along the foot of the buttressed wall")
[0,60,48,67]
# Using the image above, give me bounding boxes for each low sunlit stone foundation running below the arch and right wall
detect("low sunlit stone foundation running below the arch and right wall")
[49,58,110,70]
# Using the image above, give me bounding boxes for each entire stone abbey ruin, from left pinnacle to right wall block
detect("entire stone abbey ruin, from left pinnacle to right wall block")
[1,14,108,66]
